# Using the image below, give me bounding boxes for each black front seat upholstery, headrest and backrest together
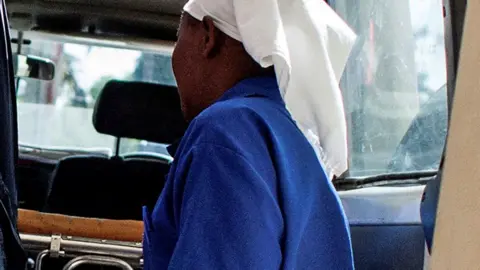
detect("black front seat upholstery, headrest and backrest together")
[45,81,186,220]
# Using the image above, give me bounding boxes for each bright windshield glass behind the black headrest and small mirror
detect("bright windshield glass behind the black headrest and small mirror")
[17,39,175,154]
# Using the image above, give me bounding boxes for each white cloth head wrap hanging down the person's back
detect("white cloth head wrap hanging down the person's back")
[184,0,356,178]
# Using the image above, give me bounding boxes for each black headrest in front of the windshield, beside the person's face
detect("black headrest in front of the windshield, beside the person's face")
[93,80,187,144]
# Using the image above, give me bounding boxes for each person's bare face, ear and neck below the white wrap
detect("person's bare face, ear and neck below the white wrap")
[172,12,274,121]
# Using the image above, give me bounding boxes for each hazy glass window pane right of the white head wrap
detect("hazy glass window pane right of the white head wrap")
[331,0,447,176]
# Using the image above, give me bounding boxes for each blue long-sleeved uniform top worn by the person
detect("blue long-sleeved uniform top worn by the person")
[143,77,353,270]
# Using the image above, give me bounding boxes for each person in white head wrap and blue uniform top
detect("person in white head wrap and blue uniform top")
[143,0,354,270]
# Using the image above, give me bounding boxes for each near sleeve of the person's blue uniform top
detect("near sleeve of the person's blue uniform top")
[169,144,283,270]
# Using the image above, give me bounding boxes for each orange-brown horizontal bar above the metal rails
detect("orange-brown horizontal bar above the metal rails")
[18,209,143,242]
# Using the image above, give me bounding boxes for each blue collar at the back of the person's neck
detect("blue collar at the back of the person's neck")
[217,76,284,104]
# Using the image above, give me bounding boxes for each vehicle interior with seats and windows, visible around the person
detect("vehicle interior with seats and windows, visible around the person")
[0,0,466,269]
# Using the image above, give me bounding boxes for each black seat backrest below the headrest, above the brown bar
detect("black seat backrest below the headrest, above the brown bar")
[46,156,168,220]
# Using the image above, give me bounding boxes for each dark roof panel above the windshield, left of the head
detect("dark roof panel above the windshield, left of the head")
[6,0,186,40]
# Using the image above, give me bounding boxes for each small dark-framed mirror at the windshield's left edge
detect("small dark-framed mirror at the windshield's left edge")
[13,54,55,81]
